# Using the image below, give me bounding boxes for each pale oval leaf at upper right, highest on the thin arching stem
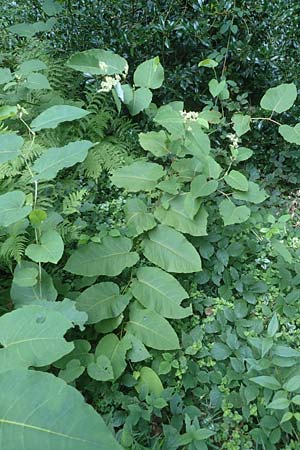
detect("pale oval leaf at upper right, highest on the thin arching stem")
[260,83,297,113]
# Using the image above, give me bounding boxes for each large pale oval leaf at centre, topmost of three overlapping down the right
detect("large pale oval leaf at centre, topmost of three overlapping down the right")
[143,225,202,273]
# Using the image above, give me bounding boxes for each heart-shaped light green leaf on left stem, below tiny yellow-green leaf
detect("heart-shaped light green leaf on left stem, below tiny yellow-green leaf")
[25,230,64,264]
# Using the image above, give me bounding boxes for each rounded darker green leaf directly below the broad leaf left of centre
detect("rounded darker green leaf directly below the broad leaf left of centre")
[76,282,131,323]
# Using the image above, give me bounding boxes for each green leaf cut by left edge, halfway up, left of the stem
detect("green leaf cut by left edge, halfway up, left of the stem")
[0,191,31,227]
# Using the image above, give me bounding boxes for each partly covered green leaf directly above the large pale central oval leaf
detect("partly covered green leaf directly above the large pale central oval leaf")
[154,194,208,236]
